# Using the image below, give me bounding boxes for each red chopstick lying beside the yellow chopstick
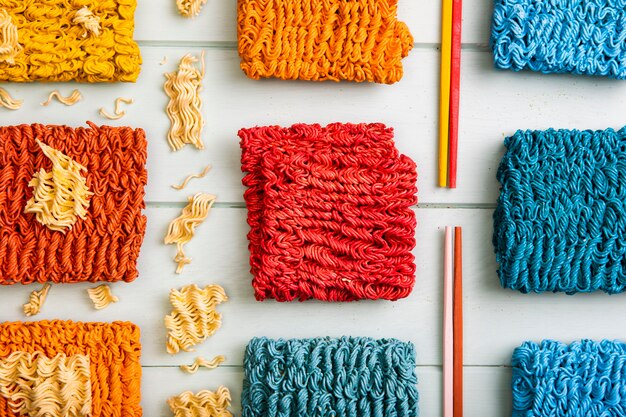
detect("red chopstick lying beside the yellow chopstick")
[448,0,463,188]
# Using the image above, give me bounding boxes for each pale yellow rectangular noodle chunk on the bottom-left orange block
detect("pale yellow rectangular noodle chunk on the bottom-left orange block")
[0,352,91,417]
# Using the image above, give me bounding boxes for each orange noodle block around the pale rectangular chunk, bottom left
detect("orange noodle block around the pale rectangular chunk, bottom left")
[0,320,141,417]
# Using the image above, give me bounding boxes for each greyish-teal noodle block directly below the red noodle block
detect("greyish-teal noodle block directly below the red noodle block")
[241,337,418,417]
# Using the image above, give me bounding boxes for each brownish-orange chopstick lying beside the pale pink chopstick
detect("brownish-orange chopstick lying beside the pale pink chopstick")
[452,227,463,417]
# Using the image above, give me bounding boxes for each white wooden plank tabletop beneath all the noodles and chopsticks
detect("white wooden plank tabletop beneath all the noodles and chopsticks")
[0,0,626,417]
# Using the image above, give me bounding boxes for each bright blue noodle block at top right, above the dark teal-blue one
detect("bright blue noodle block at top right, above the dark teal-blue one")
[491,0,626,79]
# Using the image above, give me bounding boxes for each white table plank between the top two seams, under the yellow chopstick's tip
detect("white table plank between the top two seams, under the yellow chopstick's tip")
[0,47,626,205]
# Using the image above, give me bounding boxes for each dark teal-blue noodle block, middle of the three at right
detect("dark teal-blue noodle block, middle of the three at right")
[493,128,626,294]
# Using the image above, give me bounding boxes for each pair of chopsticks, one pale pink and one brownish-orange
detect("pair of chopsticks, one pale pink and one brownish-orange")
[443,226,463,417]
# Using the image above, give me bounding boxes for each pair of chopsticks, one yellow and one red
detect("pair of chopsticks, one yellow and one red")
[439,0,463,188]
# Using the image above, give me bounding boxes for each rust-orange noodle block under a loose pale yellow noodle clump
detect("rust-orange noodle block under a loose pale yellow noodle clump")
[0,123,147,285]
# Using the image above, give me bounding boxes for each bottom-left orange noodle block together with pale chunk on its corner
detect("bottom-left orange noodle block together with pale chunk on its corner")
[0,321,141,417]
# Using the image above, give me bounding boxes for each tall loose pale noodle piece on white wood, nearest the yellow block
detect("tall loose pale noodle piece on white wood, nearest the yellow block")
[163,52,204,151]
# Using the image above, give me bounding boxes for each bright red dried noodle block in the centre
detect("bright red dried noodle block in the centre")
[239,123,417,301]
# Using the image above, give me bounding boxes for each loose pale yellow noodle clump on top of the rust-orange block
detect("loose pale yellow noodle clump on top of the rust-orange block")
[24,140,93,233]
